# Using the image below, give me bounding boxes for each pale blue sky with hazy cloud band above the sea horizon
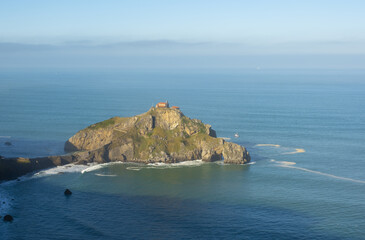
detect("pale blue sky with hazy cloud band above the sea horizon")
[0,0,365,68]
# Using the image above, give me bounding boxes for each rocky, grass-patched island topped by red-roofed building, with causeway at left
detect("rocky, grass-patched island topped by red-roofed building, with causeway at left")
[0,102,250,180]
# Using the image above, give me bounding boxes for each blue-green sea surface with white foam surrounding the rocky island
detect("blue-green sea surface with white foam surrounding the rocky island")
[0,69,365,240]
